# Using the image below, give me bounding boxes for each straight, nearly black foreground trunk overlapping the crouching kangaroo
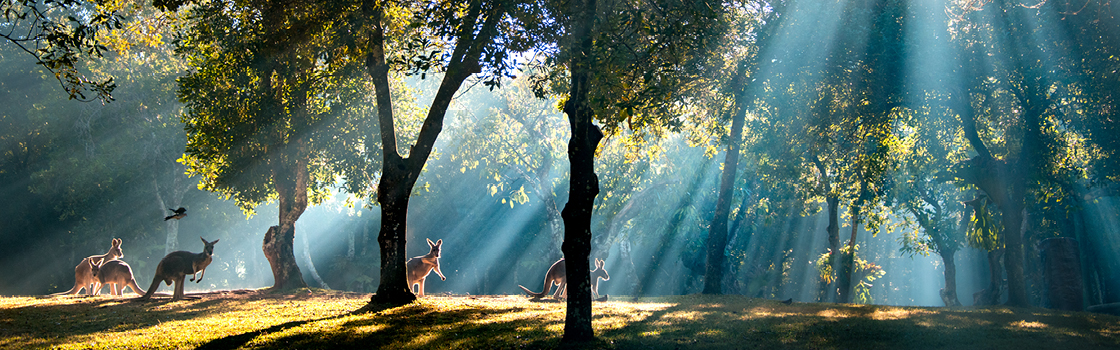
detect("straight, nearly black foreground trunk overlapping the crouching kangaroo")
[560,0,603,343]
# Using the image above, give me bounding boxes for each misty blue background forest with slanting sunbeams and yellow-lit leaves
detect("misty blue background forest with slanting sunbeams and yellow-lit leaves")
[0,0,1120,314]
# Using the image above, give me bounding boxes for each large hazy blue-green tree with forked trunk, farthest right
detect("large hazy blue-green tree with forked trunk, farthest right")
[950,1,1116,306]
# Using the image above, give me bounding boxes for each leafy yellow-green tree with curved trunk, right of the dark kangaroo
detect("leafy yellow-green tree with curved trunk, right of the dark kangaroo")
[167,1,370,292]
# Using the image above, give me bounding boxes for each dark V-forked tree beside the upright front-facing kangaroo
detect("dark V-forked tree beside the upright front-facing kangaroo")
[361,0,530,304]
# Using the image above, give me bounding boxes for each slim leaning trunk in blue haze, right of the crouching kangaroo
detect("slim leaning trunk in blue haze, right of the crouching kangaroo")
[701,63,747,294]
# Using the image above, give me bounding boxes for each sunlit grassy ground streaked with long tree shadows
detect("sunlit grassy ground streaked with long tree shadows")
[0,289,1120,350]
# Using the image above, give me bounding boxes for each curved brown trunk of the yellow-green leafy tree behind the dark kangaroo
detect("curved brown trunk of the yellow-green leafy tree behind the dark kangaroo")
[262,148,310,292]
